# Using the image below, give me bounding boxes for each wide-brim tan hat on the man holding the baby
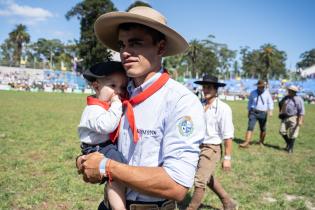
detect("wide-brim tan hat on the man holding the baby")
[94,6,189,56]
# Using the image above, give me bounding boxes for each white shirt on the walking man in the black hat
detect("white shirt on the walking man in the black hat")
[203,98,234,144]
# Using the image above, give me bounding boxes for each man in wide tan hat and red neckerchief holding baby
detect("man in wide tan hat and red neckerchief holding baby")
[77,7,205,209]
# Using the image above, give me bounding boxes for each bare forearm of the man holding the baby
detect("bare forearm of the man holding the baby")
[110,161,188,201]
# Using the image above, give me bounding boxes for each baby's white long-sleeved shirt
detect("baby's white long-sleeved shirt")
[78,101,122,145]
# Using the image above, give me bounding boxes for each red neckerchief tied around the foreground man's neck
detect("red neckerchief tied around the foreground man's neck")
[110,70,170,143]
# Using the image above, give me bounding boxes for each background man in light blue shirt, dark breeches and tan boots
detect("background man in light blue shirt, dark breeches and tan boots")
[239,80,273,148]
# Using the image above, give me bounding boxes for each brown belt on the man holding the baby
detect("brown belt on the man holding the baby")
[126,200,176,210]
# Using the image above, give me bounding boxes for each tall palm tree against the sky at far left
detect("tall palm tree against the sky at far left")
[9,24,30,65]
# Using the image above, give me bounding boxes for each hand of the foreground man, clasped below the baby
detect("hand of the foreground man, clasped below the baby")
[82,152,104,183]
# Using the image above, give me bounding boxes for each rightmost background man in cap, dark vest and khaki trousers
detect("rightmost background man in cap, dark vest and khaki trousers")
[279,85,305,153]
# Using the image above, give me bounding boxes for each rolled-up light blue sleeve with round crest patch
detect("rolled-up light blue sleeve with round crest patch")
[163,94,205,187]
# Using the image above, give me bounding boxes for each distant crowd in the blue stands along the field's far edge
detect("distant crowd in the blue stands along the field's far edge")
[0,67,315,104]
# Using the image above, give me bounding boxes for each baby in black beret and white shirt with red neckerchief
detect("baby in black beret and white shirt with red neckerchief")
[78,61,127,210]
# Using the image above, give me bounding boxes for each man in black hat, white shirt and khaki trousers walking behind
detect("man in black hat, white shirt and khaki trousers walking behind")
[187,75,237,210]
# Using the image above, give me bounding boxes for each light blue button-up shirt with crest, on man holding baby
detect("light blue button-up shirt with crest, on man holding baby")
[118,70,205,202]
